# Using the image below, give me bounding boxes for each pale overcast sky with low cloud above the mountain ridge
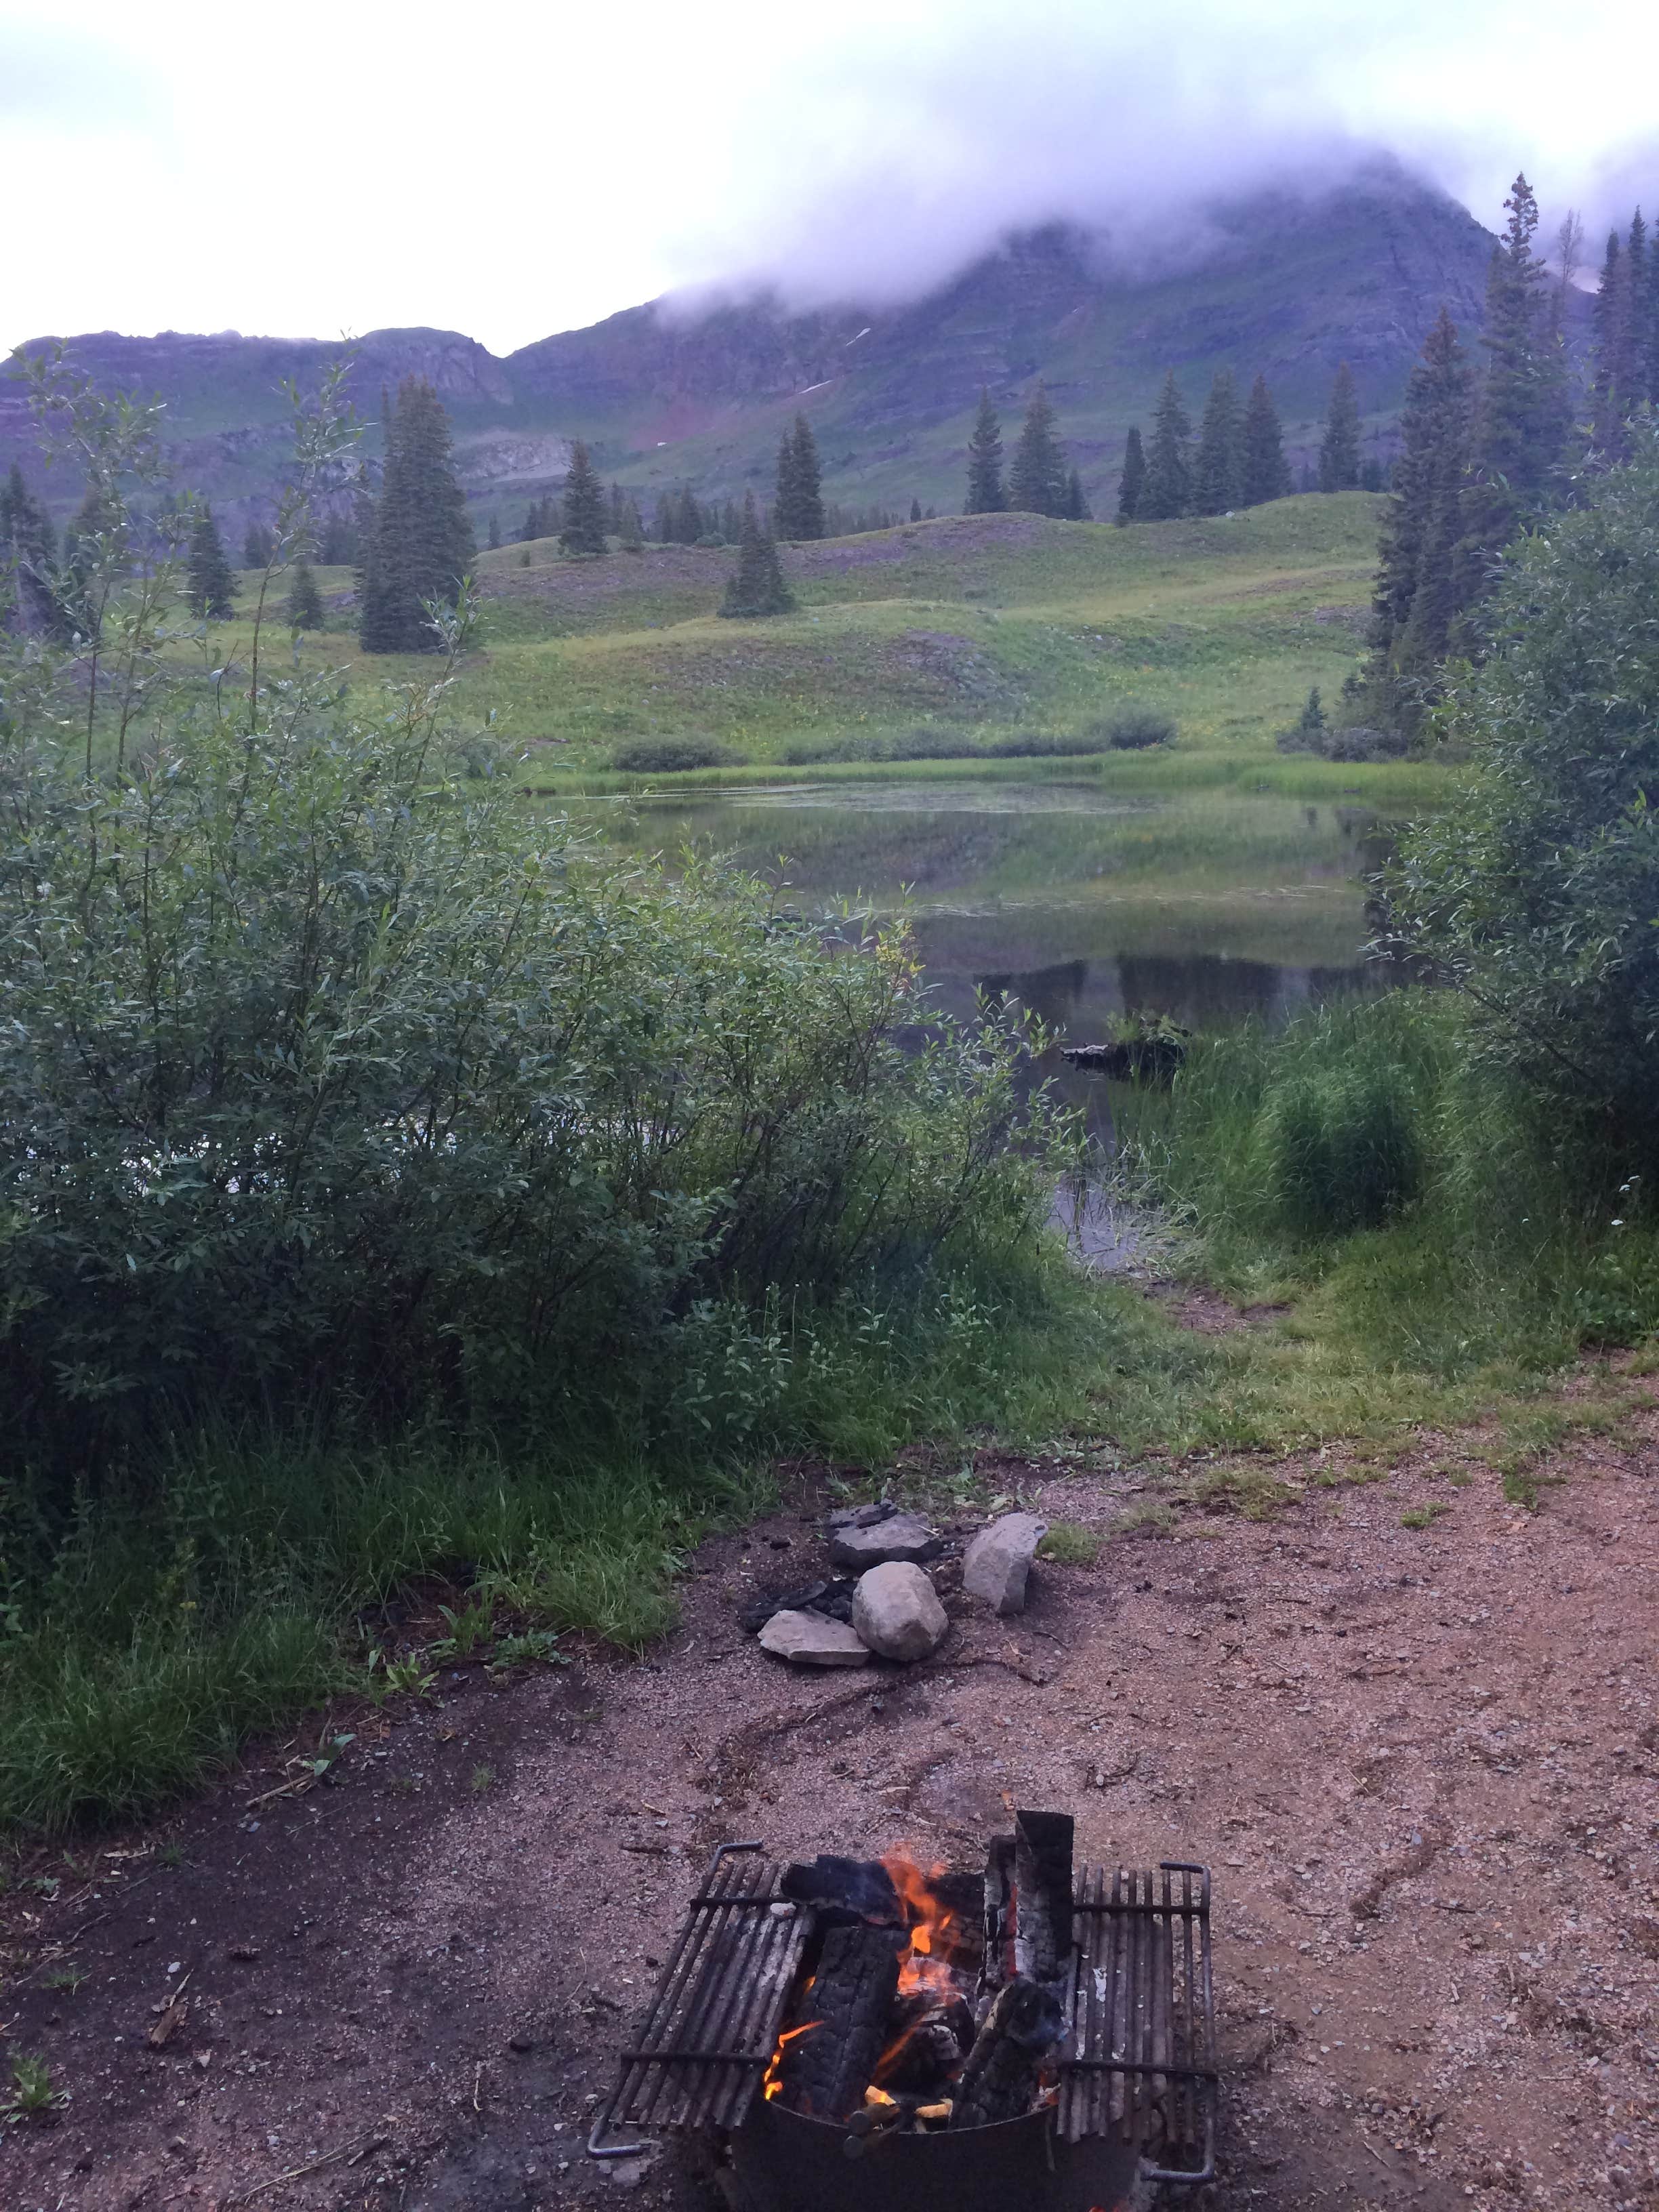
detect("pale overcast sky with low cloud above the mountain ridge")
[0,0,1659,352]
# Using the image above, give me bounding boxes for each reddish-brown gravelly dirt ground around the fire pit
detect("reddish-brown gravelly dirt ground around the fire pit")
[0,1411,1659,2212]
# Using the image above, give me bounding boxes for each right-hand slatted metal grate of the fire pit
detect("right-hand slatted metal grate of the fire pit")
[1059,1860,1218,2181]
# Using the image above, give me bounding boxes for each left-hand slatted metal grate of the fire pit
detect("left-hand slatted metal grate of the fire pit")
[588,1843,810,2159]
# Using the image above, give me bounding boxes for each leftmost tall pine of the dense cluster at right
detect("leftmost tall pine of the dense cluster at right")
[1372,308,1471,694]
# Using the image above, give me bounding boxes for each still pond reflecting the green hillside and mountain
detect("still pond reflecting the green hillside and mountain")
[569,777,1387,1137]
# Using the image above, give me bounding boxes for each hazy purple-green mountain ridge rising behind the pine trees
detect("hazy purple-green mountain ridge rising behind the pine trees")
[0,164,1521,529]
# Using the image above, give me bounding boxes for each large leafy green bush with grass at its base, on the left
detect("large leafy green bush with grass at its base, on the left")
[0,349,1092,1827]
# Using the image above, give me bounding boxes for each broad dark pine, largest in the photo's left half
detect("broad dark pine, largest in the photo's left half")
[359,376,476,653]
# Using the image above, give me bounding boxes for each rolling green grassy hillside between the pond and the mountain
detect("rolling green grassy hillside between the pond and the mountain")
[228,493,1406,787]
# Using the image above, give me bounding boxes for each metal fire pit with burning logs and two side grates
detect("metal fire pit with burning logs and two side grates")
[588,1811,1216,2212]
